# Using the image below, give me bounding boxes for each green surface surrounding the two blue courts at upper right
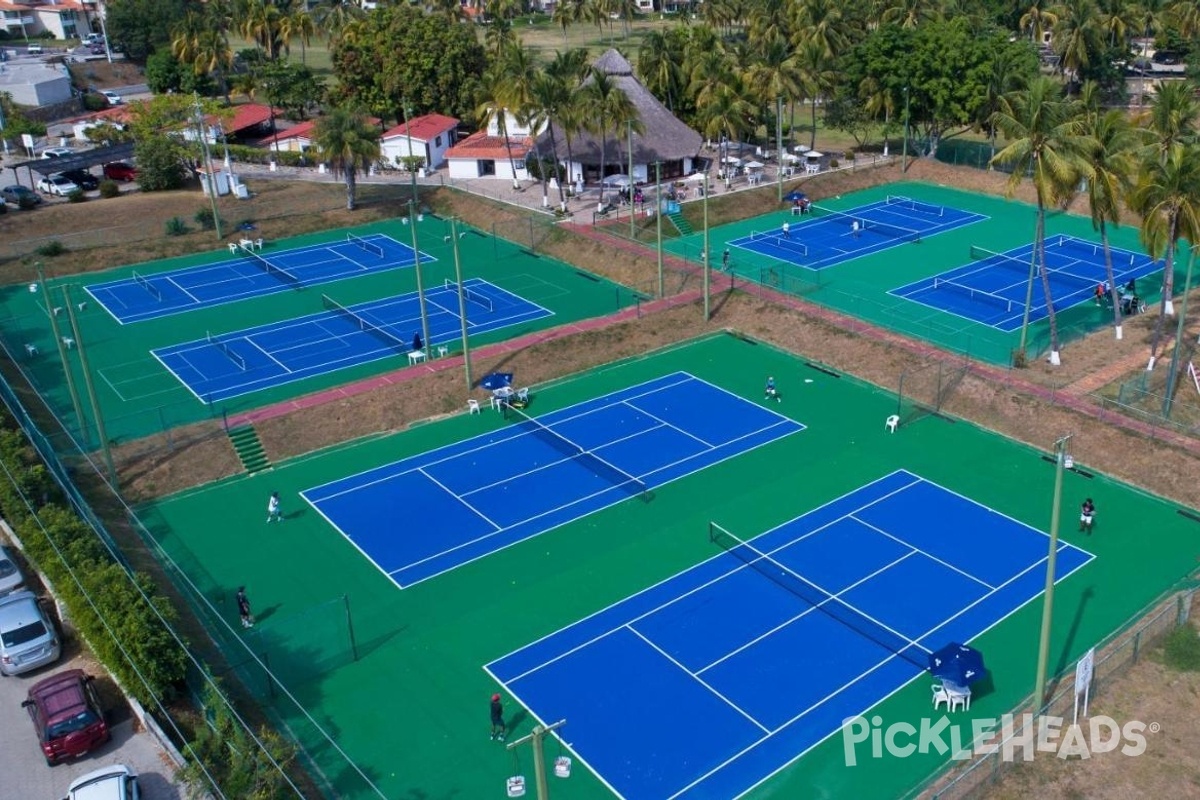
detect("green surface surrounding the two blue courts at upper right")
[664,182,1187,365]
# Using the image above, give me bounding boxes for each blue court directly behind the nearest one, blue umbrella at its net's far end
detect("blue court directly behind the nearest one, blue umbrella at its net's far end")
[301,372,804,588]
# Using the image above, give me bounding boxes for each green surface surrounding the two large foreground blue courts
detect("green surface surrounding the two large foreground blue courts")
[139,333,1200,800]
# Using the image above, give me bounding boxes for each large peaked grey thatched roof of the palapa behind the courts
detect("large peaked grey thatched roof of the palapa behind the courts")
[542,49,702,166]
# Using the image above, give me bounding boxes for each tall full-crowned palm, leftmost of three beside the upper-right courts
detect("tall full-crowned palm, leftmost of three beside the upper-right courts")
[991,76,1090,366]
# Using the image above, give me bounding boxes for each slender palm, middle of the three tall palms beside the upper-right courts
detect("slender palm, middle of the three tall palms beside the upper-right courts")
[1084,106,1139,339]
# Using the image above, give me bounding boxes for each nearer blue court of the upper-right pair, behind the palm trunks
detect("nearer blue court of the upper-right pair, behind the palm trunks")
[889,235,1163,331]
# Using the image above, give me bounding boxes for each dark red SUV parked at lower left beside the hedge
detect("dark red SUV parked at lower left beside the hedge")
[22,669,110,766]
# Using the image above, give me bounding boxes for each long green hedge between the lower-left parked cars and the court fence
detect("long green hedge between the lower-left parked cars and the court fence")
[0,422,187,706]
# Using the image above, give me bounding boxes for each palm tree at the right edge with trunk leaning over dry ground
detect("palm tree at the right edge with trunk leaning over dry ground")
[1129,144,1200,369]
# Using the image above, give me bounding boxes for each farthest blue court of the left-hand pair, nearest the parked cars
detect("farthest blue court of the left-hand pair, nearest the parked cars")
[85,234,437,325]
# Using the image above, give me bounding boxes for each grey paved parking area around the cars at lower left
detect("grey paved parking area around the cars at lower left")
[0,662,182,800]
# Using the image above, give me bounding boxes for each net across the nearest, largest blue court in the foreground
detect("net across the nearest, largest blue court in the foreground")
[708,522,930,669]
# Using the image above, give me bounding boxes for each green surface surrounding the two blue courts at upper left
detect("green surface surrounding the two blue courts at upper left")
[0,216,637,446]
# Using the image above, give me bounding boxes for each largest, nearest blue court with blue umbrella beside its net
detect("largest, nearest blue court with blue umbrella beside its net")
[485,470,1092,800]
